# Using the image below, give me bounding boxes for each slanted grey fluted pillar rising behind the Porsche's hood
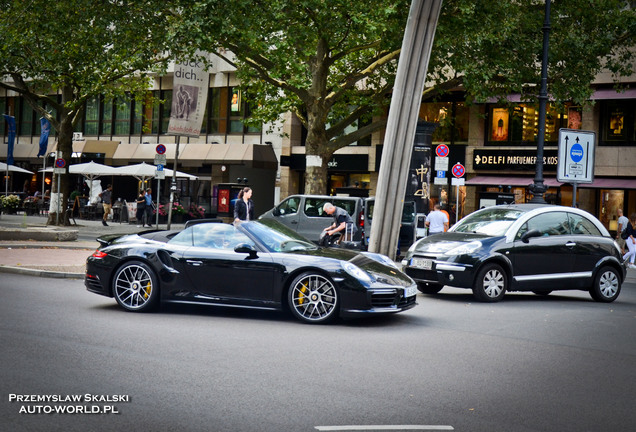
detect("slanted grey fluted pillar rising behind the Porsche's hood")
[369,0,442,257]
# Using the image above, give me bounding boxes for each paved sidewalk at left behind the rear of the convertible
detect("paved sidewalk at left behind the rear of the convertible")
[0,214,184,279]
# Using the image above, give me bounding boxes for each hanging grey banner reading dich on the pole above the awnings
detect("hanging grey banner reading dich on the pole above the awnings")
[166,52,210,137]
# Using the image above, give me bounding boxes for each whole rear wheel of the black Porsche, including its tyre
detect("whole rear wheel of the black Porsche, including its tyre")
[113,261,159,312]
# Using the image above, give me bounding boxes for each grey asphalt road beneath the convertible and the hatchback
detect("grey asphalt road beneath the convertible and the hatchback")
[0,274,636,432]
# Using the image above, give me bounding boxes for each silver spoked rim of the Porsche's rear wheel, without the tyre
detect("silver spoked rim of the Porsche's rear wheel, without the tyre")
[114,264,155,310]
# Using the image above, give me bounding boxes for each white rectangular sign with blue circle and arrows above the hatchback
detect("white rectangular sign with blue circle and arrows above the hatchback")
[557,129,596,183]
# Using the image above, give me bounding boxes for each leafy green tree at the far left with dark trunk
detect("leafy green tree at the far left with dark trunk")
[0,0,184,224]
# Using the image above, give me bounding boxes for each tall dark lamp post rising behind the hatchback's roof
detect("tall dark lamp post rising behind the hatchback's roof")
[530,0,551,204]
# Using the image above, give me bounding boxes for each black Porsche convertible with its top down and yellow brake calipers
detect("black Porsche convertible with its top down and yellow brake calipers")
[85,221,417,323]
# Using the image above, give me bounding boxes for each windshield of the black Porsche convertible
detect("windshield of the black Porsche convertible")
[242,219,317,252]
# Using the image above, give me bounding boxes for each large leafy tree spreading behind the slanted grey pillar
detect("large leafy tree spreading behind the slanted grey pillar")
[178,0,636,193]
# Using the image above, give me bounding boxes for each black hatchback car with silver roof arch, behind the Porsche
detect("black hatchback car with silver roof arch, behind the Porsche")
[402,204,626,302]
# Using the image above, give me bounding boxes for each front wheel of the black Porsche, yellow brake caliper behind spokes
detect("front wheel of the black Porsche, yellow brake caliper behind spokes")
[289,273,338,322]
